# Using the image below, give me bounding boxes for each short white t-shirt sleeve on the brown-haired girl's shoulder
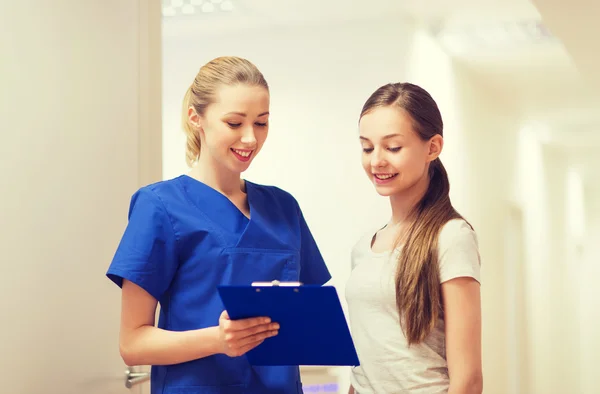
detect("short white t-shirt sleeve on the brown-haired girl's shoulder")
[438,219,481,283]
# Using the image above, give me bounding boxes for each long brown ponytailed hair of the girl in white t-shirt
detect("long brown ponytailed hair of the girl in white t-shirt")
[360,83,462,345]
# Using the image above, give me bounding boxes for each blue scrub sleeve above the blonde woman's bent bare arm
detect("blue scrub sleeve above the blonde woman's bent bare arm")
[106,188,177,300]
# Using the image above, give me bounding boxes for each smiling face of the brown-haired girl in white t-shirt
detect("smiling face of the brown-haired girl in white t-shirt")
[359,106,442,196]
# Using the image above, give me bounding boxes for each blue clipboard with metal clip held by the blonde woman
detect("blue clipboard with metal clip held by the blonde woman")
[217,282,359,366]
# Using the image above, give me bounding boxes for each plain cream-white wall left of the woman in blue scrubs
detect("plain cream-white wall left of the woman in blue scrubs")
[0,0,161,394]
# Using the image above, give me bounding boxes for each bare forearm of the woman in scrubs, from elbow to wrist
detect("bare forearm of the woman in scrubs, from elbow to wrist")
[120,326,222,366]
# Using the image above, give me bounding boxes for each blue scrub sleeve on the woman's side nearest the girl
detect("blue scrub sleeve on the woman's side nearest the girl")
[298,207,331,285]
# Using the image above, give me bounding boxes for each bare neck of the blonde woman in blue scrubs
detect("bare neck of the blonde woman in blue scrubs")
[190,154,244,197]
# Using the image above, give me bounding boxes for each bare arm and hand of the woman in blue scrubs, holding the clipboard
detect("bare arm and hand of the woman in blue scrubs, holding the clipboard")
[119,280,278,366]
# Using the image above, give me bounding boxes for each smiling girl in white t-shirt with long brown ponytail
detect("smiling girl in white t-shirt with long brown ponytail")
[346,83,483,394]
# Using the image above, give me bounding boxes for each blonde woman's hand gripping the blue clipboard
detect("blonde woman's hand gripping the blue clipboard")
[219,311,279,357]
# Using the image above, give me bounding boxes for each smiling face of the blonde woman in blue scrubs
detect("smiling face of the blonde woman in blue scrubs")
[189,84,270,173]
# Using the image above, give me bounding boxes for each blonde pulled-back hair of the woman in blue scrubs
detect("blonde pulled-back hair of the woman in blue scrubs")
[181,56,269,167]
